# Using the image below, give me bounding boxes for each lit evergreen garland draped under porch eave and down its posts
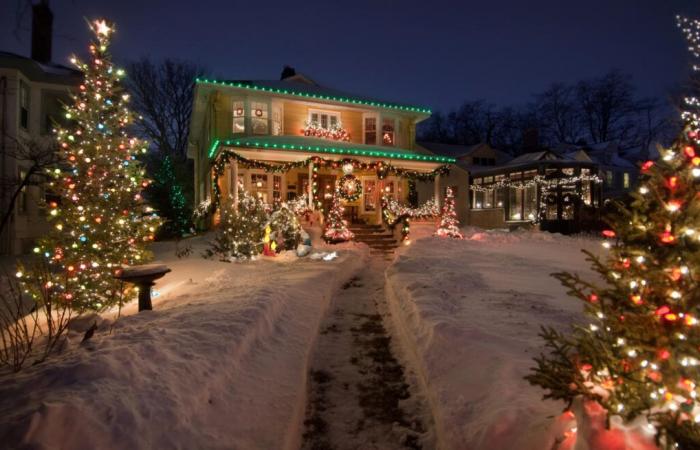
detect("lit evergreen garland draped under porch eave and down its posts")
[206,149,450,214]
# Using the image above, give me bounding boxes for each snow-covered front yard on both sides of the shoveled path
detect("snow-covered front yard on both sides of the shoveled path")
[0,225,598,450]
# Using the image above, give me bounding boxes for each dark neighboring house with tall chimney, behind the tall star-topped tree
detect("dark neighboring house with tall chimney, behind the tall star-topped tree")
[0,2,82,254]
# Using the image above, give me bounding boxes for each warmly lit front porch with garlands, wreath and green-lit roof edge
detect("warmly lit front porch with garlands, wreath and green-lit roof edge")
[205,137,450,224]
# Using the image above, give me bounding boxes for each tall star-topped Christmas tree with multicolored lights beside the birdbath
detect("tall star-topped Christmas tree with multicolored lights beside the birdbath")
[19,20,160,310]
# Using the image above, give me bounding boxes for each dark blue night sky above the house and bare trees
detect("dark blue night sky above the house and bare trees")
[0,0,700,109]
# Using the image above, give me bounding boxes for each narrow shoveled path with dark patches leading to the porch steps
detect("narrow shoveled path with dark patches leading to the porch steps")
[302,256,434,450]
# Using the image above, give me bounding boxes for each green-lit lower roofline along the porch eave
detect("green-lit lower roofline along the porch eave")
[209,139,456,164]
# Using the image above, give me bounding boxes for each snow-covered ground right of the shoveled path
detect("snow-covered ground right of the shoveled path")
[386,230,599,450]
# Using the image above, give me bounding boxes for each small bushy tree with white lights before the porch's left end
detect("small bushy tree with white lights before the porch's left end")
[205,189,268,261]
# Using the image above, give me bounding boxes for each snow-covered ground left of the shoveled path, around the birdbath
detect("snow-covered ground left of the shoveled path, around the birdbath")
[0,232,368,449]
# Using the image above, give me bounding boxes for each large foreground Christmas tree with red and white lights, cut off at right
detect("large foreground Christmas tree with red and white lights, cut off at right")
[527,15,700,449]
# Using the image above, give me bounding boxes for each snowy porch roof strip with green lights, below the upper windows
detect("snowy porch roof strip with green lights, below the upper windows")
[209,136,455,164]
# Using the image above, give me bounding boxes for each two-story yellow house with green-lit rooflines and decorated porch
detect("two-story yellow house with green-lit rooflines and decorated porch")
[188,67,468,224]
